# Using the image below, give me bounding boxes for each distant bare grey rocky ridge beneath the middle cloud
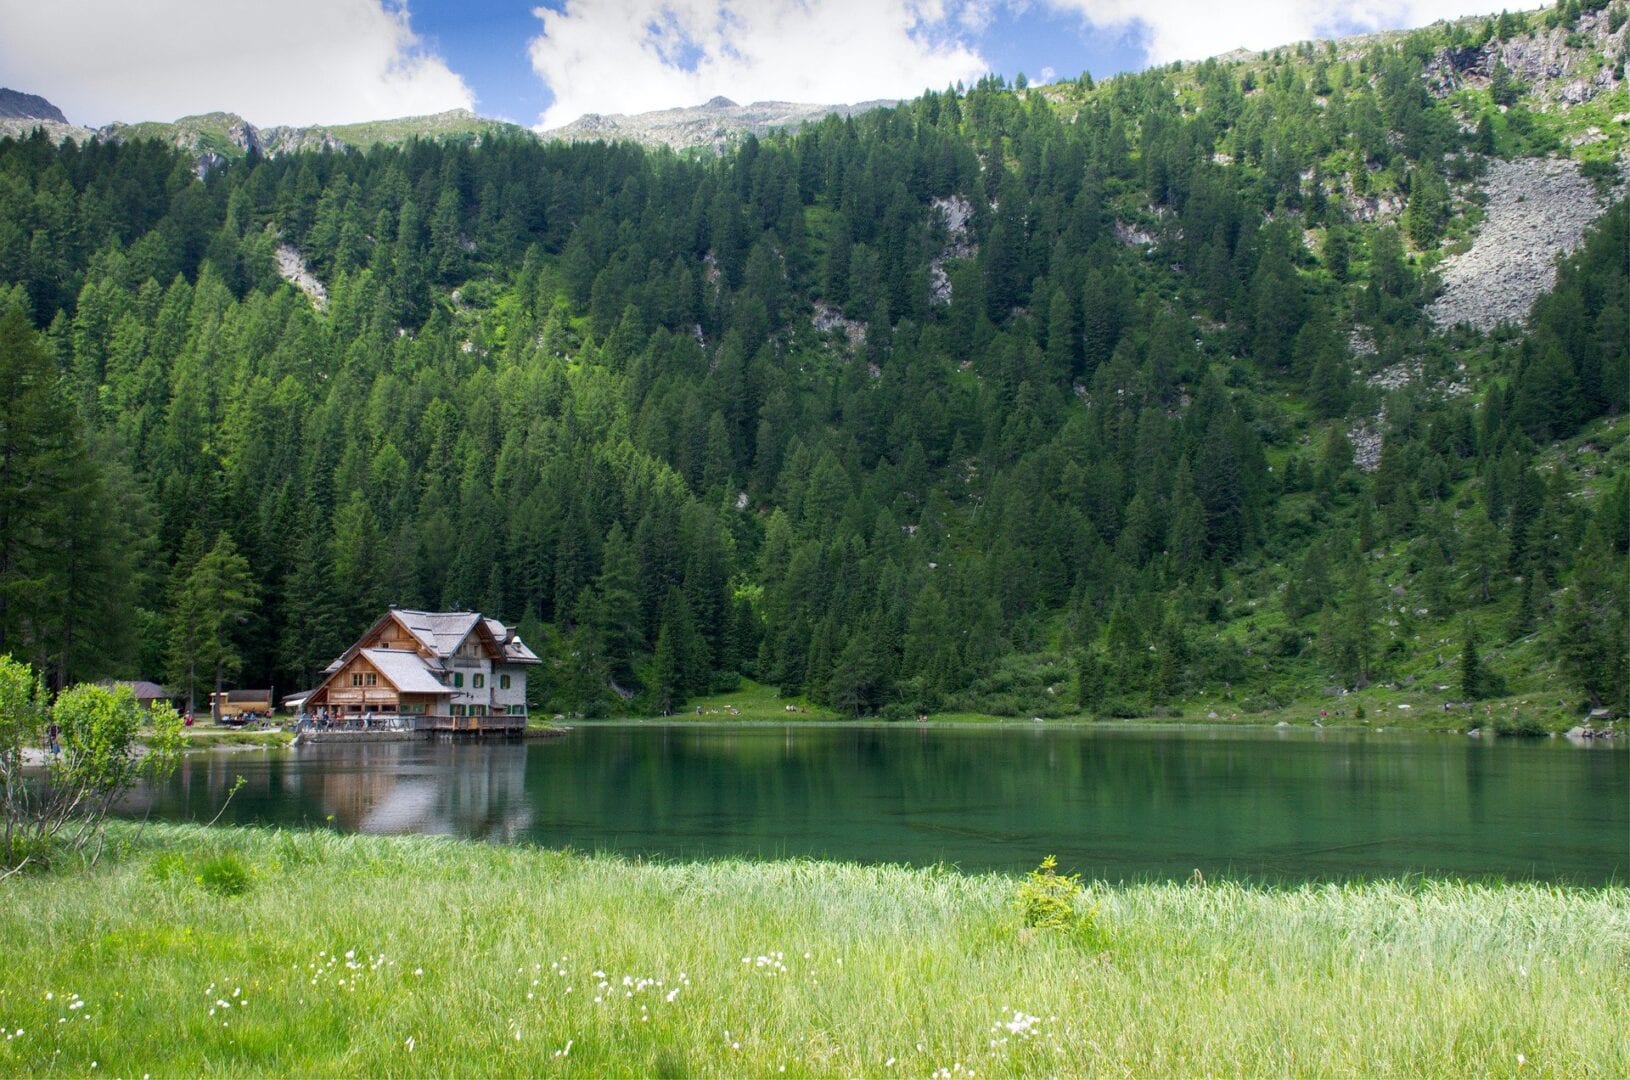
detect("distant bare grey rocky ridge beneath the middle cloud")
[541,96,897,153]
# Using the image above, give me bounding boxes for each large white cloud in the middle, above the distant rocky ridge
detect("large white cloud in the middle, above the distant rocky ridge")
[531,0,989,127]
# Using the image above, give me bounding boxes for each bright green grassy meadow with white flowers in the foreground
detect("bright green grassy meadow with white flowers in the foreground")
[0,826,1630,1077]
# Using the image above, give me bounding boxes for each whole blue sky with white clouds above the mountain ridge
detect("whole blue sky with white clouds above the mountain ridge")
[0,0,1499,127]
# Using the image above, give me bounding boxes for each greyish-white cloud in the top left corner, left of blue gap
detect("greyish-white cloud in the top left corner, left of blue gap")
[0,0,474,125]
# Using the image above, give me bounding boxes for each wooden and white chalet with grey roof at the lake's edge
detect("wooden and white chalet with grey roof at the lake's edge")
[302,608,538,733]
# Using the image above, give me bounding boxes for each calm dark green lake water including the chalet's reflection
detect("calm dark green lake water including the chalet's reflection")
[135,725,1630,883]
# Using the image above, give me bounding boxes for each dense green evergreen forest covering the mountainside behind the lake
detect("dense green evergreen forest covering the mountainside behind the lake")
[0,8,1630,715]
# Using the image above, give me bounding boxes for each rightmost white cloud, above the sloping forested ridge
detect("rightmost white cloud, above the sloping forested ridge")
[1045,0,1521,64]
